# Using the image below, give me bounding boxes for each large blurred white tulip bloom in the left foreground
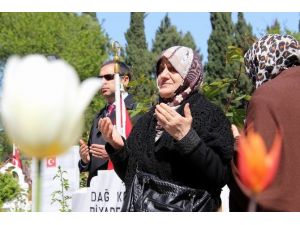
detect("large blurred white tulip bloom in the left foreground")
[1,55,101,159]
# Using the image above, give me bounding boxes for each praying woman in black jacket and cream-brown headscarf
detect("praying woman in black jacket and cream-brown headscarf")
[99,46,233,211]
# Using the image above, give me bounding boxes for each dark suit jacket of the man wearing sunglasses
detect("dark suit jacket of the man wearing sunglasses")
[78,94,136,187]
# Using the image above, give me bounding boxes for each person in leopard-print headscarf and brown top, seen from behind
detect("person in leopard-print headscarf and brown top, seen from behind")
[229,34,300,211]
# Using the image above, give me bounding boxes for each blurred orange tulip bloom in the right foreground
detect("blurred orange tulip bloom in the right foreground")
[238,129,282,194]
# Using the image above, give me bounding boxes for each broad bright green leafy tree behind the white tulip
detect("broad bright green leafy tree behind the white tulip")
[0,13,108,79]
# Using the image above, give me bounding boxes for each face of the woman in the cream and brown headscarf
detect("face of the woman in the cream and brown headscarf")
[157,63,183,98]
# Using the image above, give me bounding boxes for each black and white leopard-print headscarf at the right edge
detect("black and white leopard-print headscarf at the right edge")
[244,34,300,88]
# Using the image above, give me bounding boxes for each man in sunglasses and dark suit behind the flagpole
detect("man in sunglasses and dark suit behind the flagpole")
[78,60,136,187]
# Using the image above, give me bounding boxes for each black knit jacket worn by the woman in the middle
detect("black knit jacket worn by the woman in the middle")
[106,93,234,209]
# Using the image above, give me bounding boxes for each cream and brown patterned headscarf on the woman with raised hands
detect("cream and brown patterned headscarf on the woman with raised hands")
[157,46,204,106]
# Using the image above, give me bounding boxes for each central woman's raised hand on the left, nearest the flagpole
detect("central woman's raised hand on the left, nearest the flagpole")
[98,117,124,150]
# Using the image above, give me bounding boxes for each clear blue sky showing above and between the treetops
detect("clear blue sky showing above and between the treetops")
[97,12,300,61]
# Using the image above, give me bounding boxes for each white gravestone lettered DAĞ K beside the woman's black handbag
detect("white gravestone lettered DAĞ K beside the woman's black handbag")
[72,170,125,212]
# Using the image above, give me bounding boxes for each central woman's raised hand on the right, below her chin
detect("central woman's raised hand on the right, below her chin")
[155,103,193,141]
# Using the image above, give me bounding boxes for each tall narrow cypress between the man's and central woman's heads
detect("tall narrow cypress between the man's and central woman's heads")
[125,12,155,103]
